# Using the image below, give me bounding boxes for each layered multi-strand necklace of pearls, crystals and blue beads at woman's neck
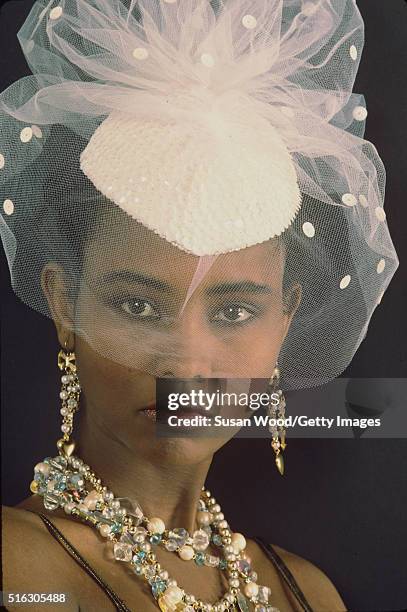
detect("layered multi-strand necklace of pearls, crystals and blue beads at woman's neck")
[30,450,279,612]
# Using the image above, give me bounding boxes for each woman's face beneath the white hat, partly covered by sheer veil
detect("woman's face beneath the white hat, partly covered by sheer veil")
[44,214,300,464]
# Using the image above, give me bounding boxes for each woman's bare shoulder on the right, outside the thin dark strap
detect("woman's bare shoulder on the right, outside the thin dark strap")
[273,544,346,612]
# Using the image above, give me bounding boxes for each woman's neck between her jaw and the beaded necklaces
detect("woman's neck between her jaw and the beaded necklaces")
[74,413,212,533]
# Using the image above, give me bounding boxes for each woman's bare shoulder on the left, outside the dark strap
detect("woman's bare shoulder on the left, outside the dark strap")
[1,506,78,612]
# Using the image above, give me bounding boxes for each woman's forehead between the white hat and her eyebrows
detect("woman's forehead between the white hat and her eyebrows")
[83,216,284,290]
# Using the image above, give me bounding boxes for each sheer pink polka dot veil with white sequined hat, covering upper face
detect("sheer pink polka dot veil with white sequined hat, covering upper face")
[0,0,398,388]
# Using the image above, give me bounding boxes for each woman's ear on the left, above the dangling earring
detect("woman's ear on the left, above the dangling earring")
[41,262,75,349]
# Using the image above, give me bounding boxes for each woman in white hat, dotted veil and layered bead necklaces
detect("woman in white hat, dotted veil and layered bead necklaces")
[0,0,398,612]
